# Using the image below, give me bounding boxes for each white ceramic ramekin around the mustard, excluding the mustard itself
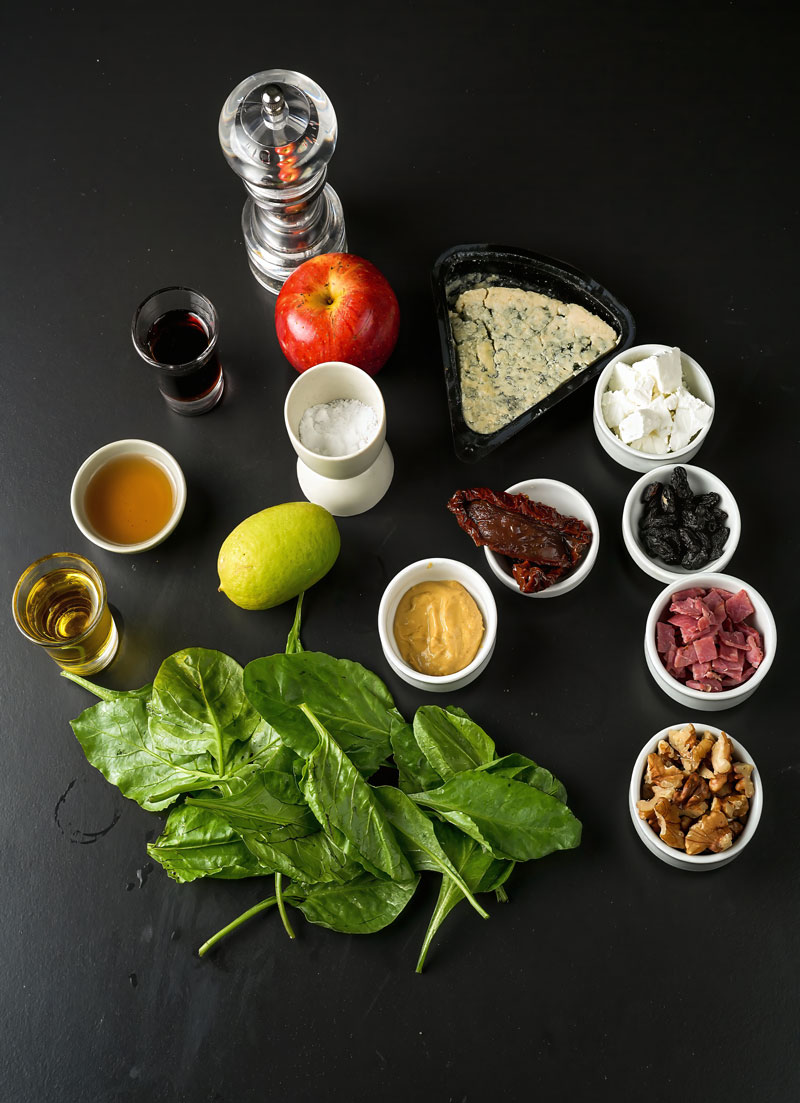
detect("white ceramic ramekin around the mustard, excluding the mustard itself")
[377,559,498,693]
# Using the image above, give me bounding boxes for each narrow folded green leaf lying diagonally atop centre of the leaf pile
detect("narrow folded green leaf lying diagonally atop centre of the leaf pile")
[300,705,414,881]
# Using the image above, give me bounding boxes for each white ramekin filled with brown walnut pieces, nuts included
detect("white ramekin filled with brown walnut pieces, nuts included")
[628,724,764,871]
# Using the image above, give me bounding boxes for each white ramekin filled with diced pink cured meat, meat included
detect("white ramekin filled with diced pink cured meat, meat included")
[644,574,778,711]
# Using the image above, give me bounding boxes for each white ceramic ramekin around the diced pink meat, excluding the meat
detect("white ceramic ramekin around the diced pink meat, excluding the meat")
[644,574,778,710]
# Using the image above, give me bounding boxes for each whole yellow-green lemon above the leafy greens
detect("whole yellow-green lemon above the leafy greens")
[216,502,341,609]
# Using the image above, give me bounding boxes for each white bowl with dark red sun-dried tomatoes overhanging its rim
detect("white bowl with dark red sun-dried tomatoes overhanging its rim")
[447,479,600,598]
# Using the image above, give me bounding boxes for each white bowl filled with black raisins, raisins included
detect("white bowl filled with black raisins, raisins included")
[622,463,742,582]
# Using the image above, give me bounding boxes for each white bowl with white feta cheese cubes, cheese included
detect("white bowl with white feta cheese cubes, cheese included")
[593,344,714,472]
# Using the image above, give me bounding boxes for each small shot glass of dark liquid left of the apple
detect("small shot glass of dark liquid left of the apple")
[130,287,225,416]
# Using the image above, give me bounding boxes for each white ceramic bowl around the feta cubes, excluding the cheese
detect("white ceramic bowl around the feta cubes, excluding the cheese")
[591,344,715,471]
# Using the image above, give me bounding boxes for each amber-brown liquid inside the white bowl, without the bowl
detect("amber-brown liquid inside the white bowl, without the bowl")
[84,453,174,544]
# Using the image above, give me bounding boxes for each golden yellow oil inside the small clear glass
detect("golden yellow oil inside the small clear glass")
[24,568,117,673]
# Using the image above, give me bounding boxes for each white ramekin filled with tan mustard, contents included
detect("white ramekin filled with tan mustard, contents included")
[377,559,498,693]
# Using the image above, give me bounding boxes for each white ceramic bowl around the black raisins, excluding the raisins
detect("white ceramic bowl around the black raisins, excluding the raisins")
[622,463,742,582]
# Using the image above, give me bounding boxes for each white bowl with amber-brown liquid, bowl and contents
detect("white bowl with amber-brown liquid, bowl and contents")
[70,439,186,555]
